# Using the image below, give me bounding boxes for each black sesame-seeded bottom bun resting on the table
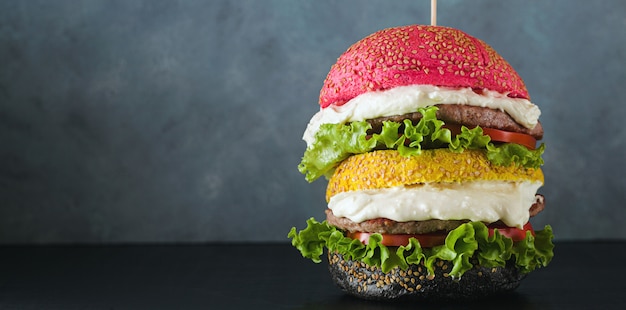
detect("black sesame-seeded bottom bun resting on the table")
[328,253,525,301]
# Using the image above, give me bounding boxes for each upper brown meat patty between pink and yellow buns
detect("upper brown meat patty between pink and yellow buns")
[367,104,543,140]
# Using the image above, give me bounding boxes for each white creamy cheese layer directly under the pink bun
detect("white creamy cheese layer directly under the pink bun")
[302,85,541,145]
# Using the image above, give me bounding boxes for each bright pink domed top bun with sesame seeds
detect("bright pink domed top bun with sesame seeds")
[319,25,529,108]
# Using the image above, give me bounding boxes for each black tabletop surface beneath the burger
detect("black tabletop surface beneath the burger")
[0,241,626,309]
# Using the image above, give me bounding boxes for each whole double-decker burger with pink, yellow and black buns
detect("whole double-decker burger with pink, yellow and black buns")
[288,25,554,300]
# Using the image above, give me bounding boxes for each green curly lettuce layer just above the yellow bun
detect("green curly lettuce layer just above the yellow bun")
[298,106,545,182]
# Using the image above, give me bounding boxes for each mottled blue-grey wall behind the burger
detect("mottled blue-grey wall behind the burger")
[0,0,626,244]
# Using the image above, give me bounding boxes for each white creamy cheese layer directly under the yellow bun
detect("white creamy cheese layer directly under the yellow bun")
[328,181,542,228]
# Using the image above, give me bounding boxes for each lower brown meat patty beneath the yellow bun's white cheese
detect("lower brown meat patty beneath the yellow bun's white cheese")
[326,194,545,234]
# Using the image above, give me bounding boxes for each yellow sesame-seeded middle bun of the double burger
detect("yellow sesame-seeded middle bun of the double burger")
[326,149,544,201]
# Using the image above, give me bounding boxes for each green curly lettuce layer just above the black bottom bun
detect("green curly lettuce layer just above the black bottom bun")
[288,218,554,277]
